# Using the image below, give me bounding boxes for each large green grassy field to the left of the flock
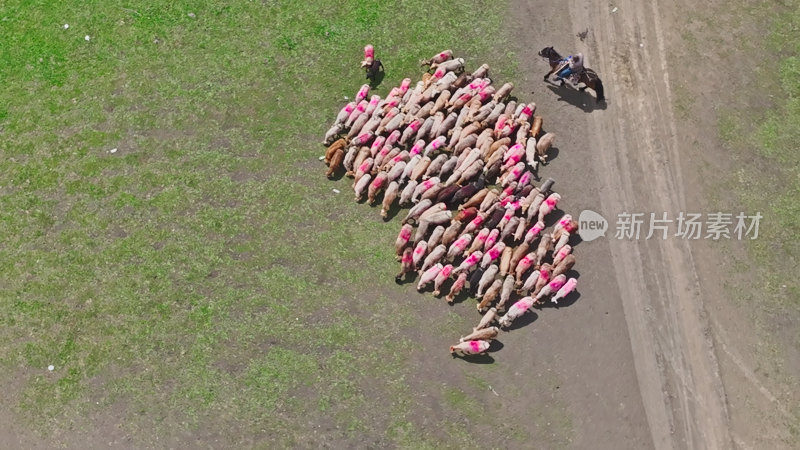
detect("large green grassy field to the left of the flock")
[0,0,552,448]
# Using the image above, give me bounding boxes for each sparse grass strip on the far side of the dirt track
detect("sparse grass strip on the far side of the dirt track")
[676,0,800,436]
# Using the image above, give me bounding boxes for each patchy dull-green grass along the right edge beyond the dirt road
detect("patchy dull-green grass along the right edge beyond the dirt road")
[692,0,800,441]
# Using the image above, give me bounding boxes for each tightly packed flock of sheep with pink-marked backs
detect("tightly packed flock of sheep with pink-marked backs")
[324,46,577,356]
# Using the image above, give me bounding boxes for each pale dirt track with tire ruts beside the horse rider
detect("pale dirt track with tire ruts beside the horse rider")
[569,0,732,449]
